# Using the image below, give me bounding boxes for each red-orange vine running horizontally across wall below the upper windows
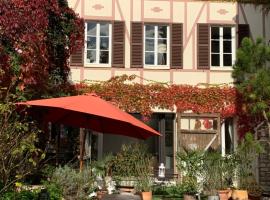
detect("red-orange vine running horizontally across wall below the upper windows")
[75,75,252,136]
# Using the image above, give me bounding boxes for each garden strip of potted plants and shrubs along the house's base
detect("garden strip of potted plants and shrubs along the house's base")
[0,134,262,200]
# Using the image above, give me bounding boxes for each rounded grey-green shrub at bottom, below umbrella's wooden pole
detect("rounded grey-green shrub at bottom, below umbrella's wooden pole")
[48,166,94,200]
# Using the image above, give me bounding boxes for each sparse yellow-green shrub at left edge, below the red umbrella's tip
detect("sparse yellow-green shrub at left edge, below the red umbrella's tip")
[0,90,45,194]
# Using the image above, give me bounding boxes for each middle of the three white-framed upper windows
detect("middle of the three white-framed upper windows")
[144,25,169,66]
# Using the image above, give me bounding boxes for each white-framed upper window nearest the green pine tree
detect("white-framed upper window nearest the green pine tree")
[211,26,235,67]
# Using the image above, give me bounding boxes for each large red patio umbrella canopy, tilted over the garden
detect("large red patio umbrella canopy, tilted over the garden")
[18,94,160,139]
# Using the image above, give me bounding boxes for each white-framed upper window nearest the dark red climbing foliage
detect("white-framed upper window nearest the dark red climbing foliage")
[85,22,112,65]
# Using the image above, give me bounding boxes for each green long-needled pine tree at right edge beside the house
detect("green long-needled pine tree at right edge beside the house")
[232,38,270,136]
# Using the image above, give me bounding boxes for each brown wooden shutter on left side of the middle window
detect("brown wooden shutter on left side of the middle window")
[131,22,143,68]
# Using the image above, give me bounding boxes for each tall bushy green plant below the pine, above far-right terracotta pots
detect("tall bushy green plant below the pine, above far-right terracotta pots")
[236,133,263,189]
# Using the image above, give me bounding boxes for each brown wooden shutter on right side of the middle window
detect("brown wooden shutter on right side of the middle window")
[171,24,183,69]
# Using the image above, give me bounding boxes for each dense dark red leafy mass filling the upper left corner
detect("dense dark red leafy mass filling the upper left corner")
[0,0,84,97]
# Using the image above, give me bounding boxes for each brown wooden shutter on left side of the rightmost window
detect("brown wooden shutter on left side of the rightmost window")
[197,24,210,69]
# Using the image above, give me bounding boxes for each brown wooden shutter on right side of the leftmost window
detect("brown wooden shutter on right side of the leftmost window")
[112,21,125,68]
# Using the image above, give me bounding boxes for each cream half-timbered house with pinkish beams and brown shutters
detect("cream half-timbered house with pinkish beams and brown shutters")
[68,0,270,189]
